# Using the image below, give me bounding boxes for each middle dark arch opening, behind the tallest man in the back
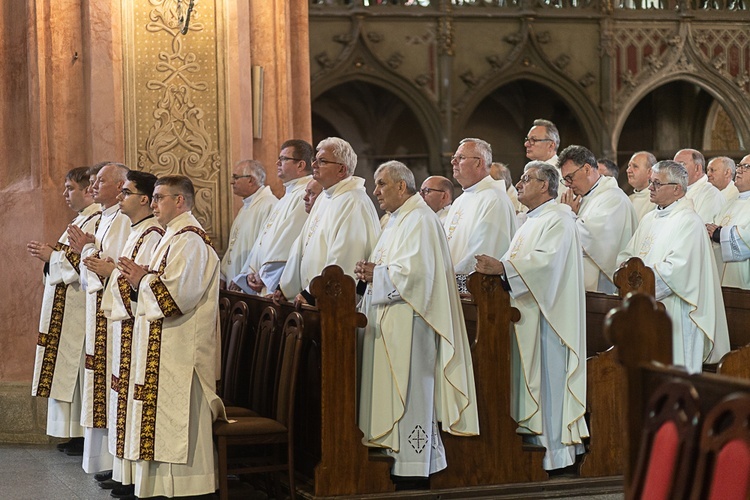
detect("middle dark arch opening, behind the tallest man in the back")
[456,80,599,181]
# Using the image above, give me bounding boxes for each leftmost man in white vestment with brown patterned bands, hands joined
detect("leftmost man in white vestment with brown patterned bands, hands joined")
[27,167,101,454]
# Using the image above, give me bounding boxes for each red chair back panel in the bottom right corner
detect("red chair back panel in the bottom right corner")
[708,439,750,500]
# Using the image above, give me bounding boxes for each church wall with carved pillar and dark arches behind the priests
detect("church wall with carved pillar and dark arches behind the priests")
[0,0,750,442]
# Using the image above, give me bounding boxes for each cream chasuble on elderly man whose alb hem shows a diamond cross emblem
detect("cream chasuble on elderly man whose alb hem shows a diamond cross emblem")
[360,195,479,472]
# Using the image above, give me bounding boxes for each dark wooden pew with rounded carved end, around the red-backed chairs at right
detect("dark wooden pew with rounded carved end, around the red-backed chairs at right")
[605,295,750,498]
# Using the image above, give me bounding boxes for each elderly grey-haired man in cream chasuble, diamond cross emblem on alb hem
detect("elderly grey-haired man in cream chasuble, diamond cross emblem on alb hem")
[355,161,479,488]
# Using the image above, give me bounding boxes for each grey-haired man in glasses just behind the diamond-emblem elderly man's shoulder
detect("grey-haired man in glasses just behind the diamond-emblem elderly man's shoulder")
[444,139,516,276]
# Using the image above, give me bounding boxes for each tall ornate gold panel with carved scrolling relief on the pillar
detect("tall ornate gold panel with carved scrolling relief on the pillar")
[123,0,228,243]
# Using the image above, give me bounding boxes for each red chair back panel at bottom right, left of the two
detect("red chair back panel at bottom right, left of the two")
[641,420,679,500]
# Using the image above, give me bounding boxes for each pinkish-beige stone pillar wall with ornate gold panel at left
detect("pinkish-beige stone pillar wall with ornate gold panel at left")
[0,0,311,442]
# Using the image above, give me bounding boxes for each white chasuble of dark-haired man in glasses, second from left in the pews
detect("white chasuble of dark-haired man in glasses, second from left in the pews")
[235,175,312,295]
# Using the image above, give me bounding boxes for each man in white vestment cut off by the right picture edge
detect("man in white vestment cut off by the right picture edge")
[706,155,750,290]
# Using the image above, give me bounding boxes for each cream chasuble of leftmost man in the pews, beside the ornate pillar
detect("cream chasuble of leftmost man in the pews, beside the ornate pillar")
[221,186,279,283]
